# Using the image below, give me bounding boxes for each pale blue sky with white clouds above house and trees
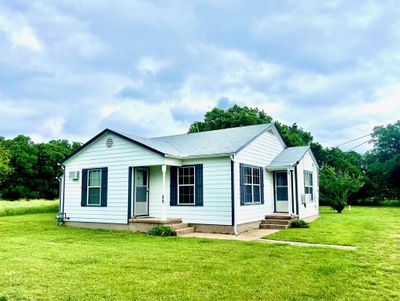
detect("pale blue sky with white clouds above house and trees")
[0,0,400,149]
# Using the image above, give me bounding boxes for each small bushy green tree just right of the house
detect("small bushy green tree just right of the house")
[320,165,364,213]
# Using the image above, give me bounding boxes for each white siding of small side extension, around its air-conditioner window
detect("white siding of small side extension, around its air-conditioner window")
[297,151,319,218]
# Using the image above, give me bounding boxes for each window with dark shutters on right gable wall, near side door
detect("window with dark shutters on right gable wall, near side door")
[244,166,261,204]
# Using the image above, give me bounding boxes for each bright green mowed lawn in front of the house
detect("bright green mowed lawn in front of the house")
[0,207,400,300]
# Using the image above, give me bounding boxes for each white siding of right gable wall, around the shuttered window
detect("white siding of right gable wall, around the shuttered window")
[235,132,284,224]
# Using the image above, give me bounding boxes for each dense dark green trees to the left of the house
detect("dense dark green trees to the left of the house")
[0,135,81,200]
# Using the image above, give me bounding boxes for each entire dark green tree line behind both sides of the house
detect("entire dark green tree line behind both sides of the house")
[0,105,400,212]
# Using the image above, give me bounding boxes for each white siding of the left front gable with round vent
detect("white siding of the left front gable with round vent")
[64,134,163,224]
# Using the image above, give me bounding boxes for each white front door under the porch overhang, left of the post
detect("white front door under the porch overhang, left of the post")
[133,167,149,216]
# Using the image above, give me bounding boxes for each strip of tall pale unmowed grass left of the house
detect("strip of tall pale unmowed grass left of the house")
[0,200,58,217]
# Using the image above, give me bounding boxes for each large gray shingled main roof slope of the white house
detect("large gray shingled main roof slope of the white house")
[121,123,273,157]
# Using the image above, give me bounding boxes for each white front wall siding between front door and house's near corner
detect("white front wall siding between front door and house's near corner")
[150,158,232,225]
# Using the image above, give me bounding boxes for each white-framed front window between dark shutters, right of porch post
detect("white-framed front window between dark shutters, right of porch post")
[178,166,195,205]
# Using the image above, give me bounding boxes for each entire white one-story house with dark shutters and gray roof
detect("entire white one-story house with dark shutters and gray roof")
[60,124,319,233]
